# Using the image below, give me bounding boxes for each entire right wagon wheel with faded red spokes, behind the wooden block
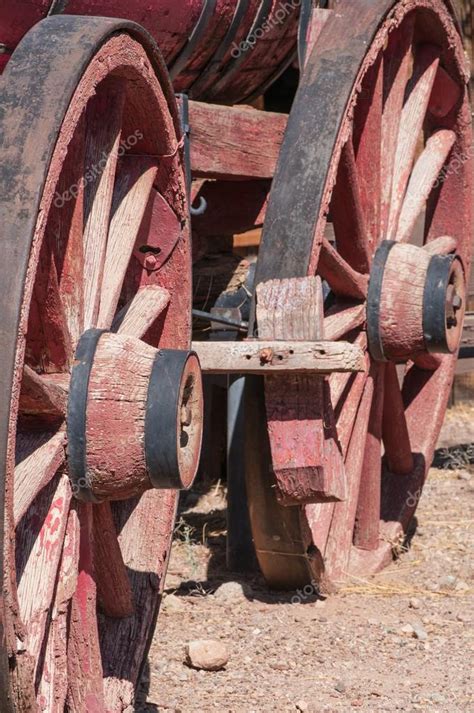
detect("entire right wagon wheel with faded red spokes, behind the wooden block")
[247,0,472,588]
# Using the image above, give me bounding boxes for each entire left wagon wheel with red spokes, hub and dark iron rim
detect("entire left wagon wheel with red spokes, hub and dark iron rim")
[0,17,201,713]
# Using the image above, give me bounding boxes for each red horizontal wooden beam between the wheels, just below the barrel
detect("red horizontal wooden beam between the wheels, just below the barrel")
[189,101,288,180]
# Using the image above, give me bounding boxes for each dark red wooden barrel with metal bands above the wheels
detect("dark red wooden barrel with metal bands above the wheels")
[0,0,301,103]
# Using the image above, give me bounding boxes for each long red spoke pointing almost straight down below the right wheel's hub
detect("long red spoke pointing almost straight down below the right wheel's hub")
[354,364,385,550]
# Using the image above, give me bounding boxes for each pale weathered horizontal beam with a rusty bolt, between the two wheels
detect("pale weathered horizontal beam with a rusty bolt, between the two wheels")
[193,340,366,374]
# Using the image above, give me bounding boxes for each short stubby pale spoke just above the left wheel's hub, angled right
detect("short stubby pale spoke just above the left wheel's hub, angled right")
[112,285,170,339]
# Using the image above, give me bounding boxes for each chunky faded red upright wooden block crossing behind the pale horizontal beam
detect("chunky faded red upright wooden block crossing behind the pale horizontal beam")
[257,277,346,505]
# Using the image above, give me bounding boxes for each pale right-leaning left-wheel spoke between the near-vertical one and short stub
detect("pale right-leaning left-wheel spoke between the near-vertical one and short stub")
[97,156,157,328]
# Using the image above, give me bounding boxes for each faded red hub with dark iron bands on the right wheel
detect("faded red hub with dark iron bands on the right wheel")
[367,240,466,361]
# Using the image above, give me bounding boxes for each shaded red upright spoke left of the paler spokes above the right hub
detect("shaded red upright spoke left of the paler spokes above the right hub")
[353,54,384,249]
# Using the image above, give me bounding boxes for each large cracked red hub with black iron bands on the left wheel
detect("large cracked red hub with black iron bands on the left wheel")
[67,329,203,502]
